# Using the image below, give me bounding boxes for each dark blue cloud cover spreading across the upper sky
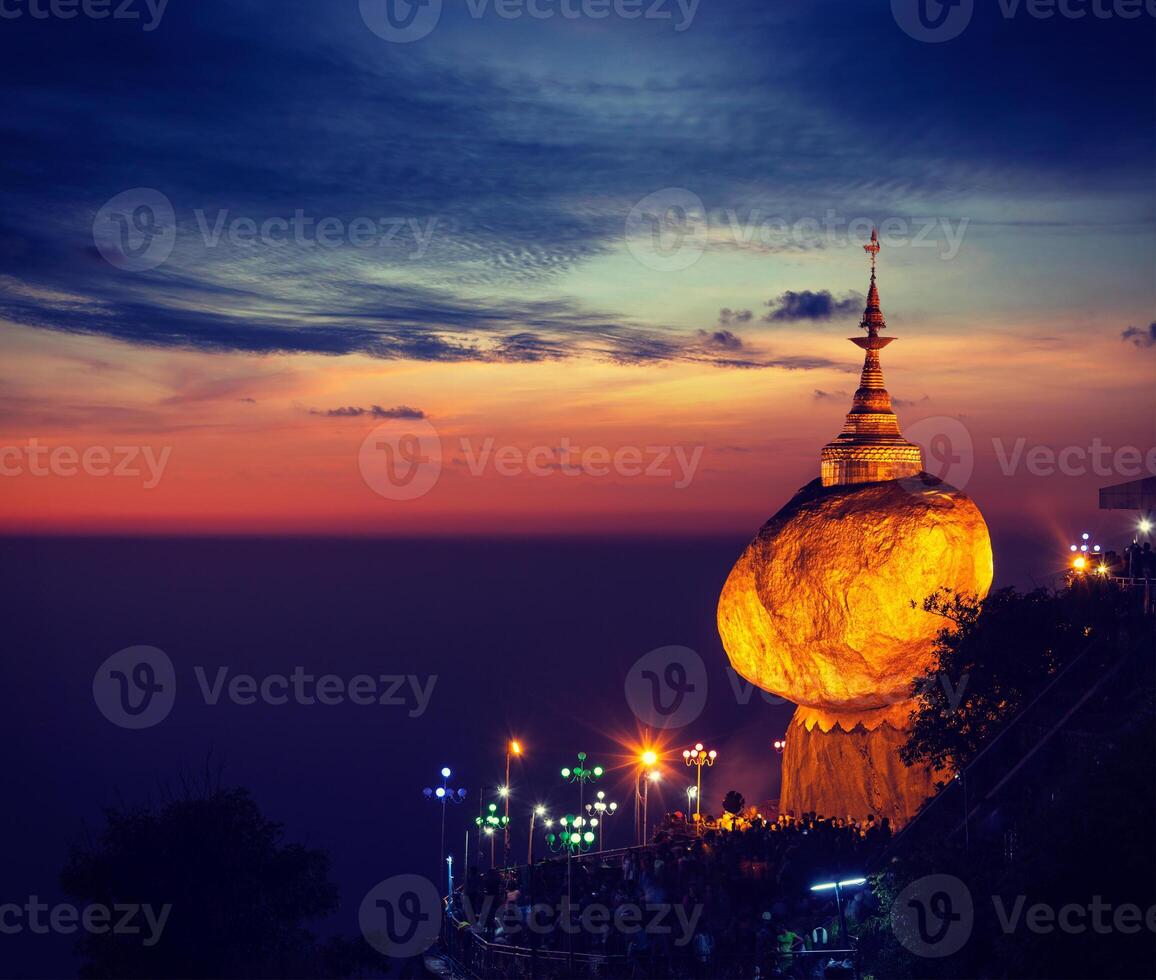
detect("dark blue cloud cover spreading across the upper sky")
[0,0,1156,366]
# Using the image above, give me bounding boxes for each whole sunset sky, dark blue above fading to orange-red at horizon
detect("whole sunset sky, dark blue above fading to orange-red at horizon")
[0,0,1156,550]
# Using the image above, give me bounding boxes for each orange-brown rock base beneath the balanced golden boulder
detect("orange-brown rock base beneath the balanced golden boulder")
[779,701,935,830]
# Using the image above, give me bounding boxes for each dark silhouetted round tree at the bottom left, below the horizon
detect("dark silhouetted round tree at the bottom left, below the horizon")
[61,788,351,978]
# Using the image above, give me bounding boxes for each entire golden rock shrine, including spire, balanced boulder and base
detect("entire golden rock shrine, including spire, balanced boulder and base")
[718,232,992,825]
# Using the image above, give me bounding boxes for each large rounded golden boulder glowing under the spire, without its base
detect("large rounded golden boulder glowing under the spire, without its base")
[718,474,992,712]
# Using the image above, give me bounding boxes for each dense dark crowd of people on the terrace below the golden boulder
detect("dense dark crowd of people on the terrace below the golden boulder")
[454,814,891,978]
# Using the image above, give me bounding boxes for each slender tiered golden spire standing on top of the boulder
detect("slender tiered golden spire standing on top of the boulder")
[821,229,924,487]
